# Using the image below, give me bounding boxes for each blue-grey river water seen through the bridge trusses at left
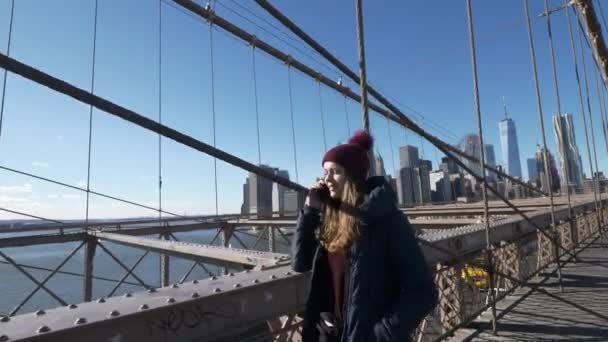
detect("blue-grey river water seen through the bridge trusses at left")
[0,230,289,316]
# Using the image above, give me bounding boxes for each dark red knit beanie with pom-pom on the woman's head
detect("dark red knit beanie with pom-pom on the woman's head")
[321,130,374,181]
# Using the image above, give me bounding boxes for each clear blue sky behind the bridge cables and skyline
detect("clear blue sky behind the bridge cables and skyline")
[0,0,608,218]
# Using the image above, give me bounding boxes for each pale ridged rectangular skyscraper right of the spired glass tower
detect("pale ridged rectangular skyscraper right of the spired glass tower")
[553,113,583,188]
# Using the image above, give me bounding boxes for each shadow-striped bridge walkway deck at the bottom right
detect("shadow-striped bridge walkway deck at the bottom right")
[450,239,608,341]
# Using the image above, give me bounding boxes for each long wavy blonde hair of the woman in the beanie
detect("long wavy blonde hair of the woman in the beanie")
[320,178,363,253]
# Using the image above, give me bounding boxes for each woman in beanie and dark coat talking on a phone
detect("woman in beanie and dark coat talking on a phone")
[292,131,437,342]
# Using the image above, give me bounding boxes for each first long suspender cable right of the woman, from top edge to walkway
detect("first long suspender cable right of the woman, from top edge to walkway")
[466,0,496,335]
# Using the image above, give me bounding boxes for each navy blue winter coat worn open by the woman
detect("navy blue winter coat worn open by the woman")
[292,177,437,342]
